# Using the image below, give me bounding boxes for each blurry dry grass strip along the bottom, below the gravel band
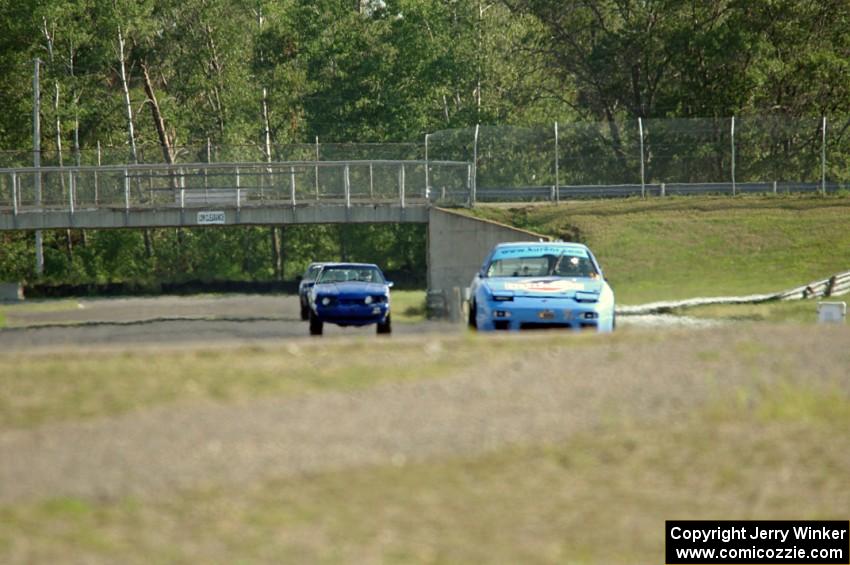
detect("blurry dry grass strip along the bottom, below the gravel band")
[0,391,850,564]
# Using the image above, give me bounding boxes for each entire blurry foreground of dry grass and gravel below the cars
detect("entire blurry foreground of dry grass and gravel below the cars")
[0,325,850,563]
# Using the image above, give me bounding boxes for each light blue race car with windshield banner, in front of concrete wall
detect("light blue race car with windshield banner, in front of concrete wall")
[469,242,615,332]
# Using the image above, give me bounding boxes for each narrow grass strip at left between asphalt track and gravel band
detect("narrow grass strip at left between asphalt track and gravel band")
[0,336,504,431]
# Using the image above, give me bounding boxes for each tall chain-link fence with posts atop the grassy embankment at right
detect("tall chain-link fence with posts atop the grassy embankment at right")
[429,117,850,199]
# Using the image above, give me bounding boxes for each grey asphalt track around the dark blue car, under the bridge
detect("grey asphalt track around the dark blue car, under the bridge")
[0,295,463,351]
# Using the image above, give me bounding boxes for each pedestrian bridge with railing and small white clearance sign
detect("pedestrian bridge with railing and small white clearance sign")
[0,160,475,230]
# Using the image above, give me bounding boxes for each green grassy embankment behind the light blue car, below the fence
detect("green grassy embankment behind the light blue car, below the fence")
[474,196,850,304]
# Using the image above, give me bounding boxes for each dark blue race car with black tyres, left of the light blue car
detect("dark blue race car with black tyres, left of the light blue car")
[309,263,393,335]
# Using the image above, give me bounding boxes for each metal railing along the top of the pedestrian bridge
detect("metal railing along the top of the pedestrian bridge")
[0,160,473,214]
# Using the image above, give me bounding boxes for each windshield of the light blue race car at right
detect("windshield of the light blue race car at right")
[487,249,598,277]
